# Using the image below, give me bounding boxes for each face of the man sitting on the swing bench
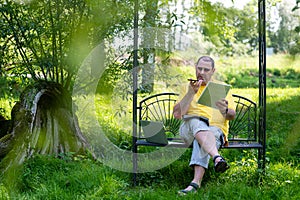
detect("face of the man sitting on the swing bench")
[196,60,215,84]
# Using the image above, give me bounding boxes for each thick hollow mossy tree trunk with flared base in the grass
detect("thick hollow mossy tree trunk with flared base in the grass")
[0,81,89,171]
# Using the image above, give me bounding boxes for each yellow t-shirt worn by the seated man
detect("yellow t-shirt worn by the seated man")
[178,80,235,141]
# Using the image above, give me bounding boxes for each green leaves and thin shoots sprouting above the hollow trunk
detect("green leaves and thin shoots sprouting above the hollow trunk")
[0,0,133,92]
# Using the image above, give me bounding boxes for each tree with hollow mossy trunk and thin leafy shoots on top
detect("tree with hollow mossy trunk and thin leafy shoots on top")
[0,0,132,180]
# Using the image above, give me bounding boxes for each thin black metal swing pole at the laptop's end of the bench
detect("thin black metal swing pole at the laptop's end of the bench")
[132,0,139,186]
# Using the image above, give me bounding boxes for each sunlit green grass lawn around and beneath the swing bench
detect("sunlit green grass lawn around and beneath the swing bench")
[0,56,300,200]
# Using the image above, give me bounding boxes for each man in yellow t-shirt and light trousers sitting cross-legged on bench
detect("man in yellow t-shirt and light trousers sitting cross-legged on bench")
[173,56,235,194]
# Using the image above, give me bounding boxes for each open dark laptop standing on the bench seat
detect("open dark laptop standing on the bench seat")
[140,120,168,145]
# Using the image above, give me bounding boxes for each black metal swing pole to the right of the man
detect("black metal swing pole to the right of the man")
[258,0,266,170]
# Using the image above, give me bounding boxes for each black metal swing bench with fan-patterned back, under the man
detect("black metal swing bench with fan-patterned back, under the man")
[133,93,264,182]
